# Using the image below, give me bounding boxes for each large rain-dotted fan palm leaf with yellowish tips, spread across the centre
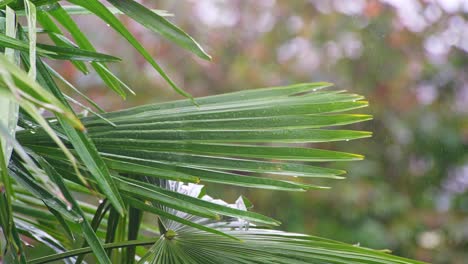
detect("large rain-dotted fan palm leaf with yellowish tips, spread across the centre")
[18,84,370,194]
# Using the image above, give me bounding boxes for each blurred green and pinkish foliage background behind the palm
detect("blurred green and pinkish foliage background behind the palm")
[50,0,468,263]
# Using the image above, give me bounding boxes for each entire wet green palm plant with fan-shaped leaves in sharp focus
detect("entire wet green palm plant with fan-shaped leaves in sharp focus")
[0,0,424,263]
